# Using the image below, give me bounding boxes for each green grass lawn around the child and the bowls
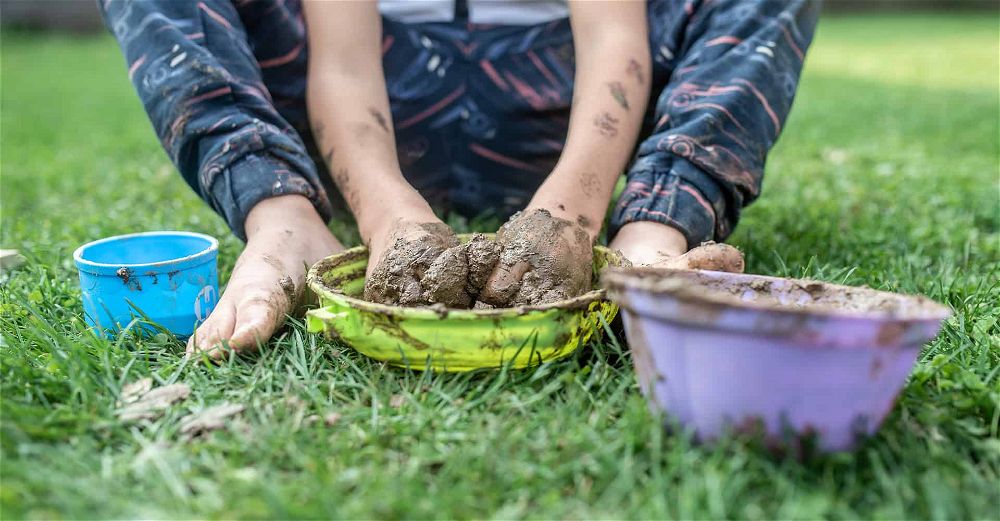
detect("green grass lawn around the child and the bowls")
[0,14,1000,519]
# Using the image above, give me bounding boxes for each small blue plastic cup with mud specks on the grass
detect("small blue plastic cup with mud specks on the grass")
[73,232,219,338]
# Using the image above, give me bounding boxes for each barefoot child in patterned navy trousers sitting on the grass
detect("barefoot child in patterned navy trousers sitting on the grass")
[102,0,818,356]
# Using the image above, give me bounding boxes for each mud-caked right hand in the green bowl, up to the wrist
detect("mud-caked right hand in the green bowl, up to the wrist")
[479,208,593,307]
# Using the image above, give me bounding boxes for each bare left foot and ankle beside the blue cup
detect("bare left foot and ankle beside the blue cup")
[187,195,344,359]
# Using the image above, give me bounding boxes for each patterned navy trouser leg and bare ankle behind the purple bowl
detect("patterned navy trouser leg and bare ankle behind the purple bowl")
[610,0,820,264]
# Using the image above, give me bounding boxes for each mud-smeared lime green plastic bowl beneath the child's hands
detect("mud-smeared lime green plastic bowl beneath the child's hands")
[306,235,625,372]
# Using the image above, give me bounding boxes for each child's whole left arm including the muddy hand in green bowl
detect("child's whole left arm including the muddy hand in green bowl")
[304,1,454,294]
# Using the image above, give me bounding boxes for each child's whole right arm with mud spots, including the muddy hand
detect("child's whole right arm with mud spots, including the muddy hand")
[480,0,651,305]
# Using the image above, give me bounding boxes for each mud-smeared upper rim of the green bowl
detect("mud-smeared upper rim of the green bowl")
[306,234,627,320]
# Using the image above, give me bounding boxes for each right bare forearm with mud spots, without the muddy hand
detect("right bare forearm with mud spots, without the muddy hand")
[532,2,650,237]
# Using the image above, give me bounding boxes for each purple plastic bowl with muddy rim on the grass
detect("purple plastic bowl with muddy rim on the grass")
[603,269,950,451]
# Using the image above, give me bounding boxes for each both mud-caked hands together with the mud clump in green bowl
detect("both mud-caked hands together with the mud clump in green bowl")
[364,210,593,309]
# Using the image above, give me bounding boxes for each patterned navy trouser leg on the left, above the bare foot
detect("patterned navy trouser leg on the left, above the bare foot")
[99,0,331,239]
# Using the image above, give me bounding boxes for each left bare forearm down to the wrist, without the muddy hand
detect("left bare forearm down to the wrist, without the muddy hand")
[305,2,433,242]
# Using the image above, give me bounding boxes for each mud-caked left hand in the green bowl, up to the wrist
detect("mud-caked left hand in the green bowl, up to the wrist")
[365,220,471,308]
